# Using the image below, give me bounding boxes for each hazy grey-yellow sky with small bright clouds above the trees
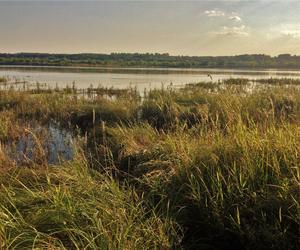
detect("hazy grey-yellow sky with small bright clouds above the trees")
[0,0,300,55]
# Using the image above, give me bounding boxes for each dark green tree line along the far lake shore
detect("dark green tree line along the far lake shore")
[0,53,300,68]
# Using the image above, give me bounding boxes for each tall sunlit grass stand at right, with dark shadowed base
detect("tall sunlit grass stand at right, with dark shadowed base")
[106,122,300,249]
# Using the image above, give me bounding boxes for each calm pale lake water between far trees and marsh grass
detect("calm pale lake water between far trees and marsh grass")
[0,66,300,91]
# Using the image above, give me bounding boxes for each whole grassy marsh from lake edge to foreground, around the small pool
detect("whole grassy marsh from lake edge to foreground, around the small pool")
[0,79,300,249]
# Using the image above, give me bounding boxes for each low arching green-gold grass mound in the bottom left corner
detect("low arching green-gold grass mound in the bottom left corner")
[0,153,176,249]
